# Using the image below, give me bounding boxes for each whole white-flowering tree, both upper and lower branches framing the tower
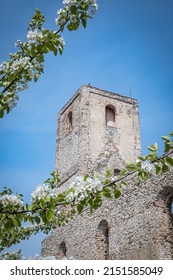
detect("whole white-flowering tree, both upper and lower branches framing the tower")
[0,0,173,258]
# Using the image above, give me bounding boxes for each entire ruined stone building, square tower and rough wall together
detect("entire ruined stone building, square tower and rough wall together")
[42,86,173,259]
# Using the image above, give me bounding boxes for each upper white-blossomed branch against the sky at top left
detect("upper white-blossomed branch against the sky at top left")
[0,0,98,118]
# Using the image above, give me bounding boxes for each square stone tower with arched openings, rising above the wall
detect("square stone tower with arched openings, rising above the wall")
[56,85,141,182]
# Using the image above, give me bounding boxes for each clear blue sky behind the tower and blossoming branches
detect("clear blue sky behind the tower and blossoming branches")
[0,0,173,256]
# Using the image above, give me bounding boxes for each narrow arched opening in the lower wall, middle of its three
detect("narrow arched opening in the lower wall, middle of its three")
[95,220,109,260]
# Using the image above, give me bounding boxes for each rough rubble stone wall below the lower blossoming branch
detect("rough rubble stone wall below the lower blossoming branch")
[42,167,173,259]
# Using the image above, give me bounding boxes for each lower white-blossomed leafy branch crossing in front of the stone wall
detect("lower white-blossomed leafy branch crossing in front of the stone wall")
[0,132,173,253]
